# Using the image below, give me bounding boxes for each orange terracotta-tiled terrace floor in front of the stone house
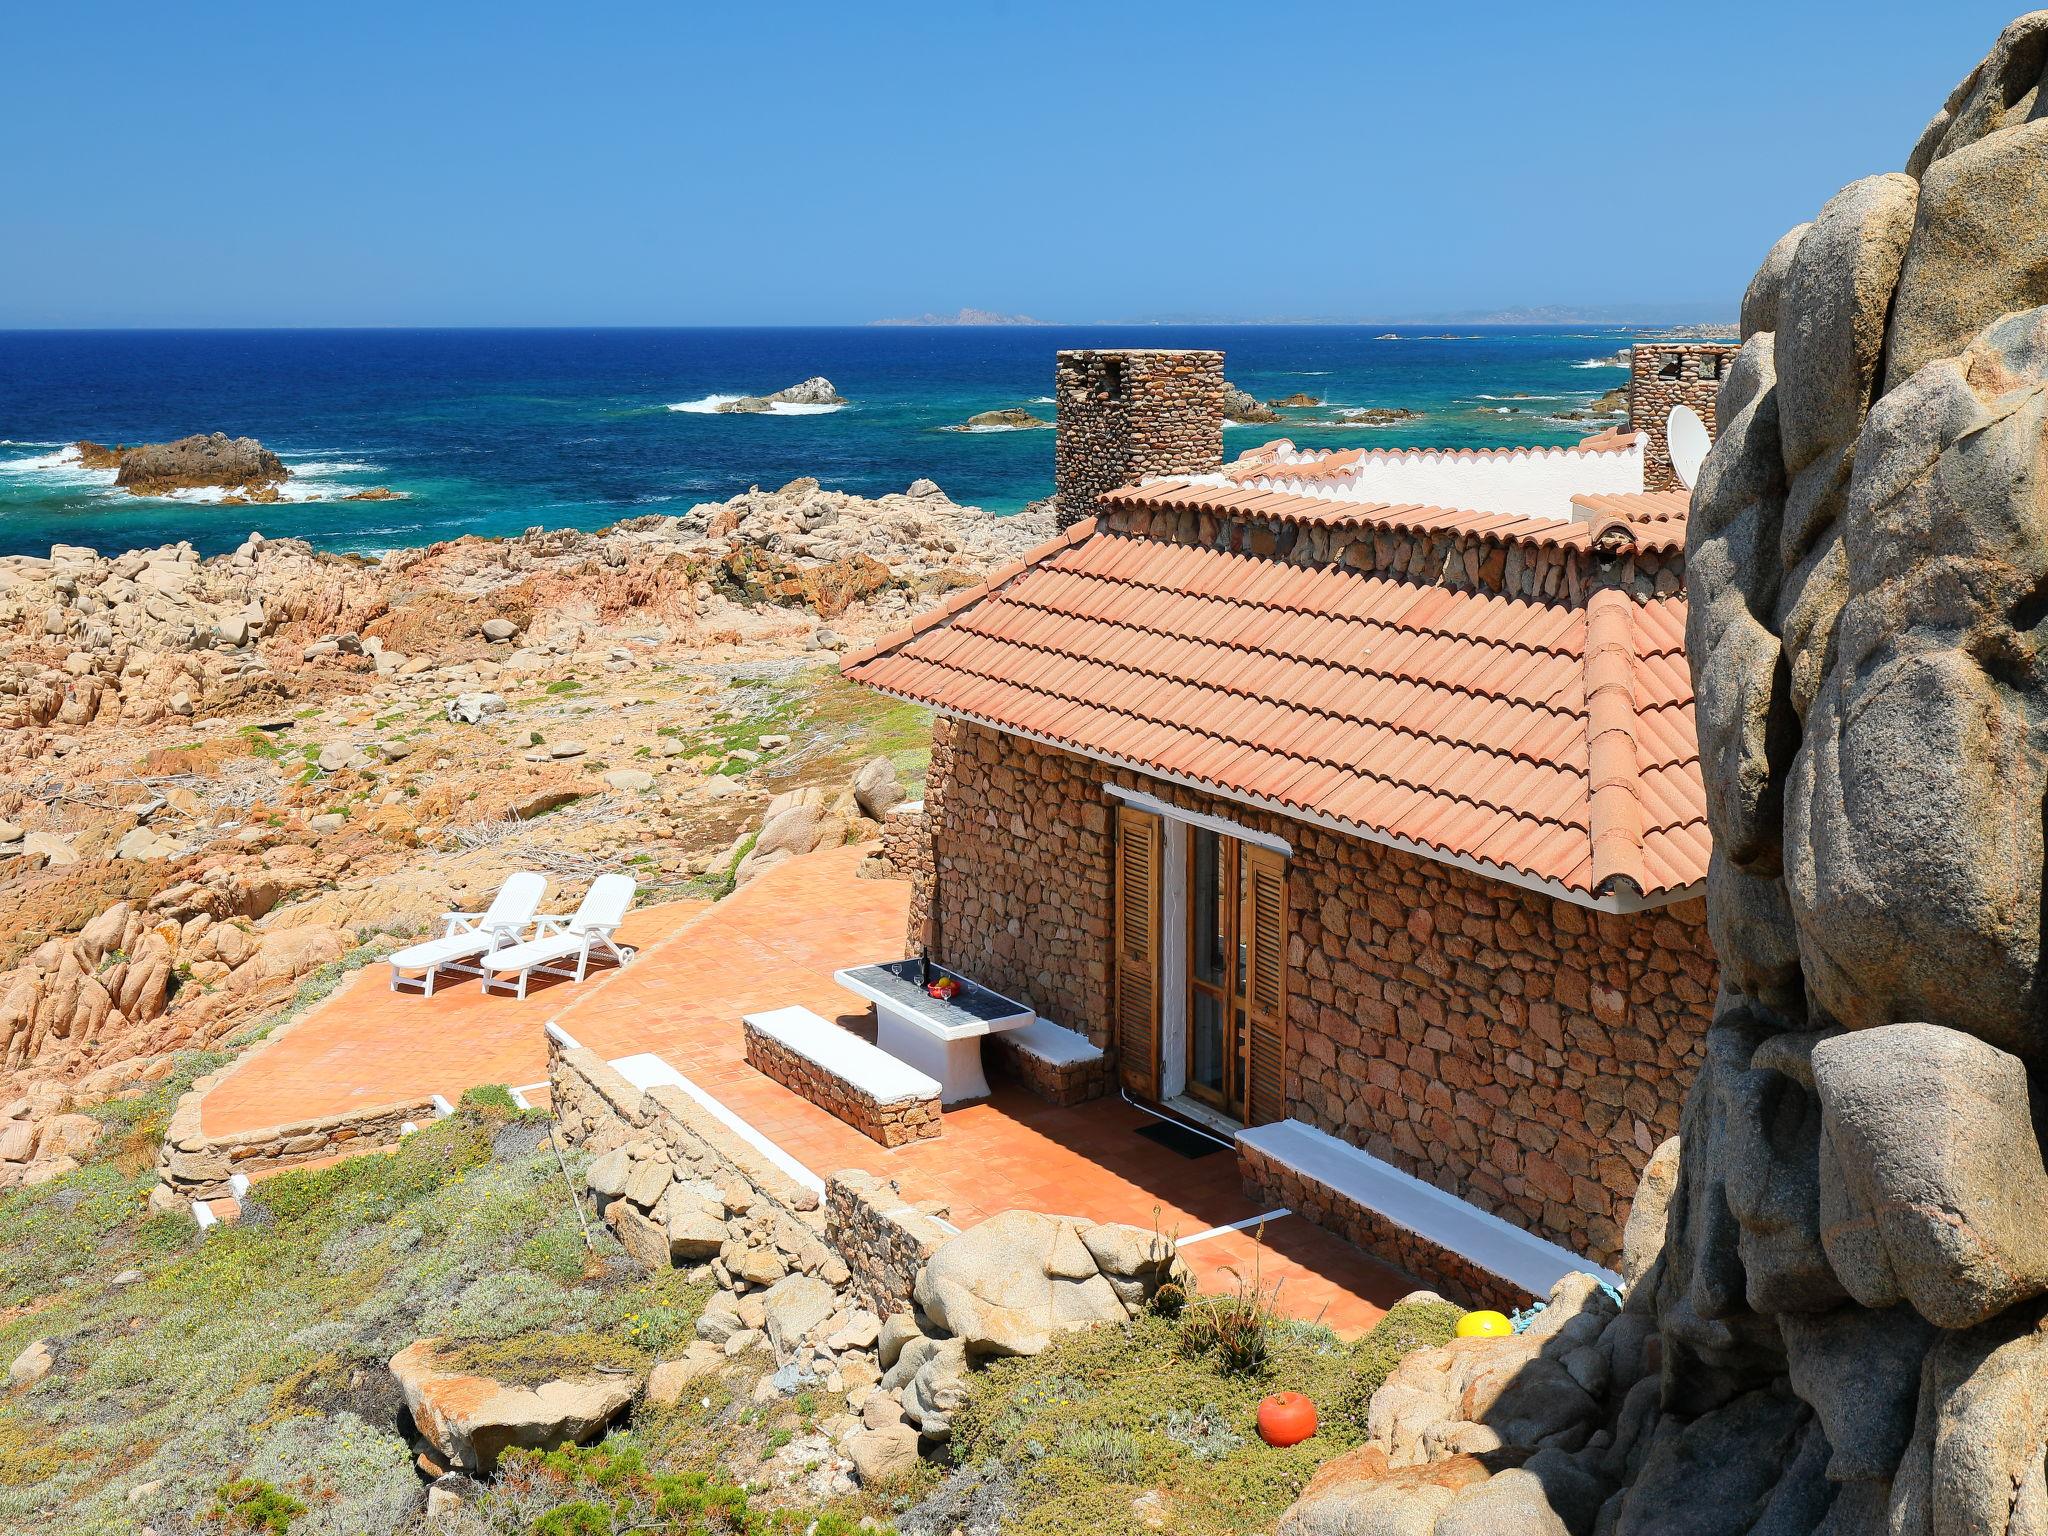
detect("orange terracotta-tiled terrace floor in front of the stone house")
[203,848,1413,1335]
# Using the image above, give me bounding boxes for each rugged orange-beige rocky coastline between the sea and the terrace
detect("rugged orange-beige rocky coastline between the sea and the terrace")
[0,479,1053,1188]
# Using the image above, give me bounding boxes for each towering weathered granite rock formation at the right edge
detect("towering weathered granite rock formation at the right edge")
[1292,12,2048,1536]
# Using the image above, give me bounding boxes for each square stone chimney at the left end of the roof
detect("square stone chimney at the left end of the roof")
[1053,348,1223,528]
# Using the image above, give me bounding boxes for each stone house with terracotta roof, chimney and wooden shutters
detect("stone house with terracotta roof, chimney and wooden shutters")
[844,348,1716,1294]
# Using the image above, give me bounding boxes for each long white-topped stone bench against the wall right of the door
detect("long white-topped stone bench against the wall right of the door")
[1237,1120,1620,1311]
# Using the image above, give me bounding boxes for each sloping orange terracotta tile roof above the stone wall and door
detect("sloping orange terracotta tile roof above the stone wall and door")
[844,524,1708,899]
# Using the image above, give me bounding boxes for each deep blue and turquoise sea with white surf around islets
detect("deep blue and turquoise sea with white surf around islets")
[0,326,1632,553]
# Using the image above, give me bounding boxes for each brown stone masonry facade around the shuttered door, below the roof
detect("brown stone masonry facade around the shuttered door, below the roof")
[913,723,1716,1266]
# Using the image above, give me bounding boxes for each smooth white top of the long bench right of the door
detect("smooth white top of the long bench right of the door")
[1237,1120,1622,1296]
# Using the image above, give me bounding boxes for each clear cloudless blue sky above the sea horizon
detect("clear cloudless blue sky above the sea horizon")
[0,0,2017,328]
